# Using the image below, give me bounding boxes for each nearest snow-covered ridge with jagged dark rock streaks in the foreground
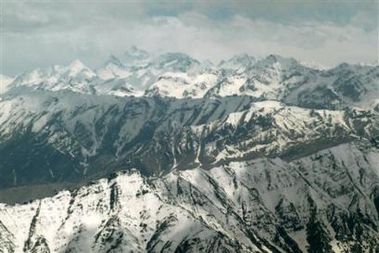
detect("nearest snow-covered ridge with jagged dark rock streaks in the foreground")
[0,143,379,252]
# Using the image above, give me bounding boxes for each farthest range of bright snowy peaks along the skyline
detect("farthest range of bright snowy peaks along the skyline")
[4,47,379,108]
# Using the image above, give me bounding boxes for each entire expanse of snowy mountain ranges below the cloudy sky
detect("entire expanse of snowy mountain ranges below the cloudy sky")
[0,47,379,252]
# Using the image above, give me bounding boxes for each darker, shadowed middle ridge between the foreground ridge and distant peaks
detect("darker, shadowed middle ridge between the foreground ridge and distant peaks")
[0,89,379,191]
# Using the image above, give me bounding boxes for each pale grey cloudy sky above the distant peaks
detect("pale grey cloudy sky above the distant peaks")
[0,0,378,76]
